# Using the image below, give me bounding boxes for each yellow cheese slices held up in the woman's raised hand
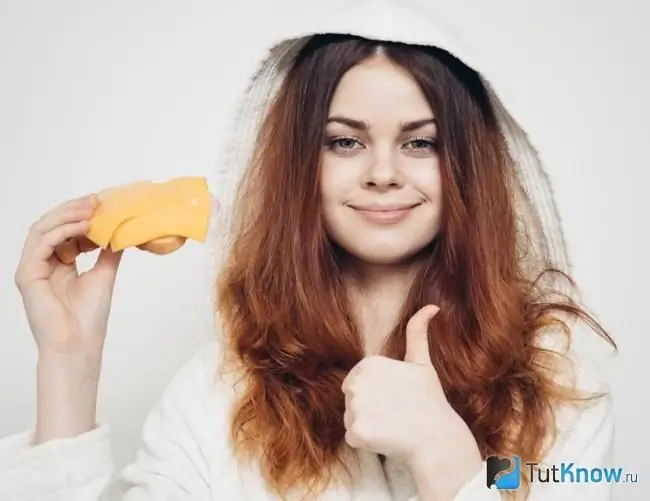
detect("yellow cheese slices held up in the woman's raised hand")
[87,177,211,251]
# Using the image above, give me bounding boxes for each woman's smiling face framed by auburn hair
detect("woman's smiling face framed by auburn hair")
[320,55,442,264]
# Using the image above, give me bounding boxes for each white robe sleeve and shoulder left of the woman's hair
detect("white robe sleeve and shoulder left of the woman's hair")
[0,343,223,501]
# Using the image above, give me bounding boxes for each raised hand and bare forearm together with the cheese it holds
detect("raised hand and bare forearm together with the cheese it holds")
[15,177,211,444]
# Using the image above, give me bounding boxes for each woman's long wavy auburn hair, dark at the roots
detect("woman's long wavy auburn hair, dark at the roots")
[216,35,614,496]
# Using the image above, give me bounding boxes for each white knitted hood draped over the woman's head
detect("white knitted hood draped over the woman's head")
[209,0,570,292]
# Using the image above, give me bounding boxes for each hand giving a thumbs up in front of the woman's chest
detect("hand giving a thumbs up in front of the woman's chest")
[342,305,482,499]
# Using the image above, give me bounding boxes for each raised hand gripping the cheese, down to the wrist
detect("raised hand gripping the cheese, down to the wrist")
[15,191,122,360]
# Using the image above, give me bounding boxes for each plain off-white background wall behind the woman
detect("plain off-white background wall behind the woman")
[0,0,650,501]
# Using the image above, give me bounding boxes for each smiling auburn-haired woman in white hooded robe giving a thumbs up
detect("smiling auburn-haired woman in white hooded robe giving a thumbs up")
[0,2,613,501]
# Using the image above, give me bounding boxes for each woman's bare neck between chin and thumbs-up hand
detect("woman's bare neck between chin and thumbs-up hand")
[344,252,422,355]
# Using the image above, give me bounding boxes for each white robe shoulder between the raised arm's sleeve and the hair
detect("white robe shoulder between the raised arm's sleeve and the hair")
[105,342,243,499]
